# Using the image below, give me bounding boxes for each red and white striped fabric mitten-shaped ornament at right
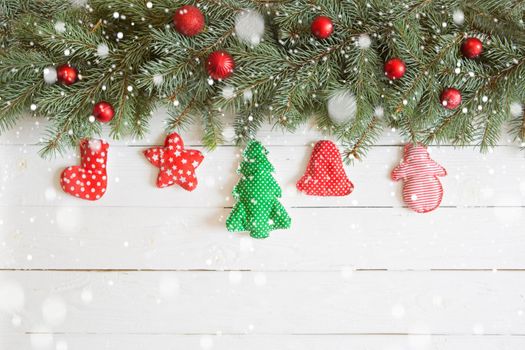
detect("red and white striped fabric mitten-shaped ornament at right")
[392,144,447,213]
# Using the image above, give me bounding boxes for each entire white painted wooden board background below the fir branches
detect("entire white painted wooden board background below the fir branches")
[0,108,525,350]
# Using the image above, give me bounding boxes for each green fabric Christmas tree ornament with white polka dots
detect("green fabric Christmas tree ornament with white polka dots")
[226,140,292,238]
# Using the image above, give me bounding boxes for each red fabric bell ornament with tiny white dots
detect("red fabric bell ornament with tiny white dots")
[297,140,354,196]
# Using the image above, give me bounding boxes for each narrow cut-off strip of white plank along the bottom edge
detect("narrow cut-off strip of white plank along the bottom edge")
[0,333,525,350]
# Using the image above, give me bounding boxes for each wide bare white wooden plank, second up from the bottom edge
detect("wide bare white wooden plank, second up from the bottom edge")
[0,271,525,335]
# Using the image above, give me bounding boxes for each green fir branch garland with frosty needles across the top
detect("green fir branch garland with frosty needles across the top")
[0,0,525,160]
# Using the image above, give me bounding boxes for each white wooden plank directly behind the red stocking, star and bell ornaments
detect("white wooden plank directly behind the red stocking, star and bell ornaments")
[0,146,525,208]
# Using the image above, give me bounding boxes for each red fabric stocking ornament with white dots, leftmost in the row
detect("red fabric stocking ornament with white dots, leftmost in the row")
[60,139,109,201]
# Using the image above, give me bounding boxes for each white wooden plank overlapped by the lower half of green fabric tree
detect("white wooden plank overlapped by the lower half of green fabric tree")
[0,207,525,273]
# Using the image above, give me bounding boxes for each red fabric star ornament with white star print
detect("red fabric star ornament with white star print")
[144,133,204,191]
